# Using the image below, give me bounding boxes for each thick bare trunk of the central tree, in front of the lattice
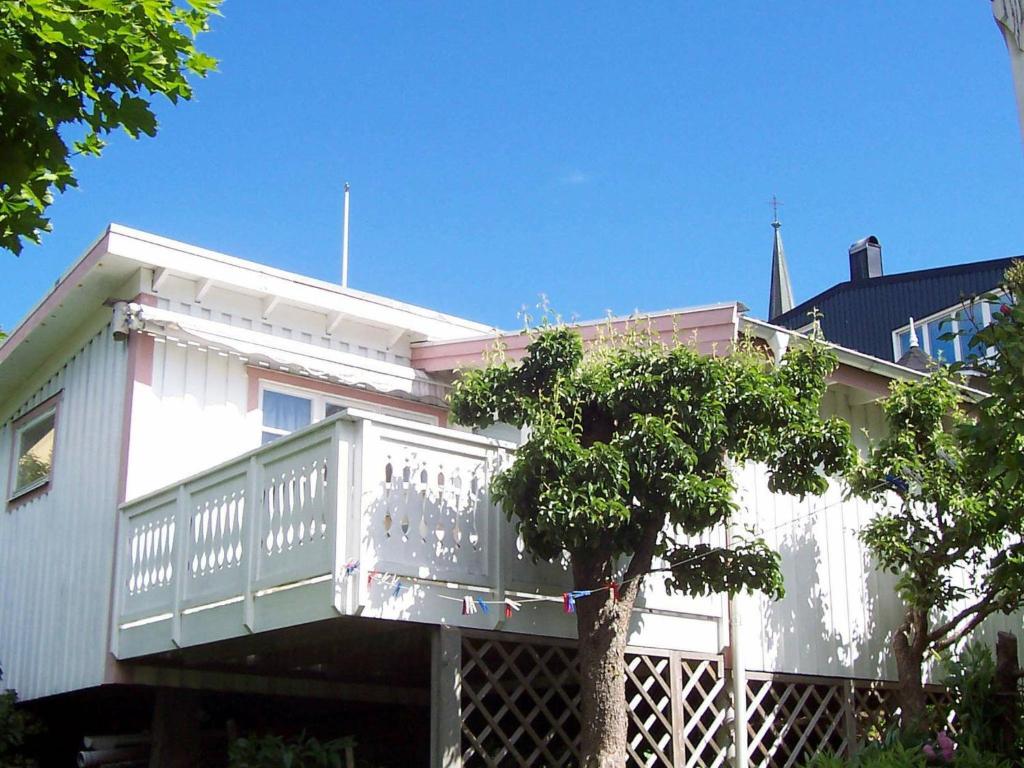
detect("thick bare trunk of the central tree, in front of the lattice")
[572,528,659,768]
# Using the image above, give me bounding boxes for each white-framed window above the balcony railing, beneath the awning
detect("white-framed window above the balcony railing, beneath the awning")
[261,384,437,445]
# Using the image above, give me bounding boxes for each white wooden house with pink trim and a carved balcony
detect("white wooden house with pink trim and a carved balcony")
[0,225,1019,766]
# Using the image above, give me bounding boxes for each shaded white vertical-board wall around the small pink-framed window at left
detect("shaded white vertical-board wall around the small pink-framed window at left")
[0,327,127,698]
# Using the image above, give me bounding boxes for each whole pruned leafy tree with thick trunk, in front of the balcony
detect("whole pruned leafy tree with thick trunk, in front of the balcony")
[451,327,850,768]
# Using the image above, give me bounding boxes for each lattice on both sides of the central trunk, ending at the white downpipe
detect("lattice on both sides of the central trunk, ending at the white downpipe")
[461,636,727,768]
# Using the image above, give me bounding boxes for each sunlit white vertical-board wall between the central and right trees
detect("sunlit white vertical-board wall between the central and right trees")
[740,388,900,678]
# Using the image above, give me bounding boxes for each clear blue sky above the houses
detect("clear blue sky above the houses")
[0,0,1024,330]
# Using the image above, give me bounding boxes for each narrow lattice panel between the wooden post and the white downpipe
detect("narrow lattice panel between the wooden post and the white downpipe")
[679,658,731,768]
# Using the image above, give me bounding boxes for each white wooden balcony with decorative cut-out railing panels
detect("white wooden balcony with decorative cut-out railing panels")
[112,409,721,659]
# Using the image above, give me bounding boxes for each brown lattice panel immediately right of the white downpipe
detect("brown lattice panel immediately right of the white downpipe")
[746,676,849,768]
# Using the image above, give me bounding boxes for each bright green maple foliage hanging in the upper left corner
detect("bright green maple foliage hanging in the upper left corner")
[0,0,220,254]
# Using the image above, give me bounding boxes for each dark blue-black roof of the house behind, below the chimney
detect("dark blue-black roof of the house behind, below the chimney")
[771,256,1024,360]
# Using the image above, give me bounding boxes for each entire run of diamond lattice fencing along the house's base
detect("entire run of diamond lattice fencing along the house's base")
[461,634,955,768]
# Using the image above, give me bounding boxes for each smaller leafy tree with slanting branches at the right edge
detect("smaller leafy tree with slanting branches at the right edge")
[850,268,1024,729]
